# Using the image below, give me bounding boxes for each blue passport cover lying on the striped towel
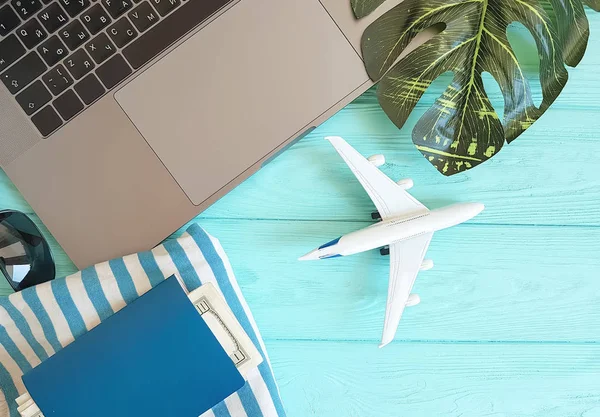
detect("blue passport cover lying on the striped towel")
[23,277,244,417]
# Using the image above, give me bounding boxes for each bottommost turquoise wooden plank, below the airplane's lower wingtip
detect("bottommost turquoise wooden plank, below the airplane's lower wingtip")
[267,341,600,417]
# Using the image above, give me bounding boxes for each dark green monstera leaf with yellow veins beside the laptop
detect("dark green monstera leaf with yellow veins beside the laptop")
[351,0,600,175]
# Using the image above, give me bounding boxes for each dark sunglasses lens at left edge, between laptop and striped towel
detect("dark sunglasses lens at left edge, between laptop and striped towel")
[0,210,56,291]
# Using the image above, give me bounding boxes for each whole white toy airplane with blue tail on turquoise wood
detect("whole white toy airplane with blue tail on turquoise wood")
[300,137,484,347]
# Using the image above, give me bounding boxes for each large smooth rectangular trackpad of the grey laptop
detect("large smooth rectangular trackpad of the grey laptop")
[115,0,367,205]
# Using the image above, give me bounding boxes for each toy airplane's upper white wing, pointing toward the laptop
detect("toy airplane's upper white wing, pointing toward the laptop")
[325,136,429,219]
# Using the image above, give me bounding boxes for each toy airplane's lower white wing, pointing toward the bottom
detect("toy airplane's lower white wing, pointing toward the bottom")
[379,232,433,347]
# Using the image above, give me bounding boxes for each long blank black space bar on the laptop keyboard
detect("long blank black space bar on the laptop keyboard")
[123,0,228,69]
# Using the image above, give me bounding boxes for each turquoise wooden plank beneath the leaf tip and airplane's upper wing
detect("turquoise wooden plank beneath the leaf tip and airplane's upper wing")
[190,97,600,225]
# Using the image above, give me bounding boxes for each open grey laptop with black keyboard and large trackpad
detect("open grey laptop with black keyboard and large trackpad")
[0,0,399,268]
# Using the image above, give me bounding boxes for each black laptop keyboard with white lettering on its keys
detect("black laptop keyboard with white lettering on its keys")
[0,0,232,136]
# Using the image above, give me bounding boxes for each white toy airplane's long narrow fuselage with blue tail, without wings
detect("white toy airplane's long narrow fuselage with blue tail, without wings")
[300,203,484,261]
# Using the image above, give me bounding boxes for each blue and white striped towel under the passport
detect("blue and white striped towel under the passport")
[0,225,285,417]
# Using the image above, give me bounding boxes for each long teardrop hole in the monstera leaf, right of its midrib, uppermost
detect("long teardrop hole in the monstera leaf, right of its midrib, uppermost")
[506,22,544,108]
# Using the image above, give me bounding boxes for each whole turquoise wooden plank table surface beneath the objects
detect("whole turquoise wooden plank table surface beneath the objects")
[0,15,600,417]
